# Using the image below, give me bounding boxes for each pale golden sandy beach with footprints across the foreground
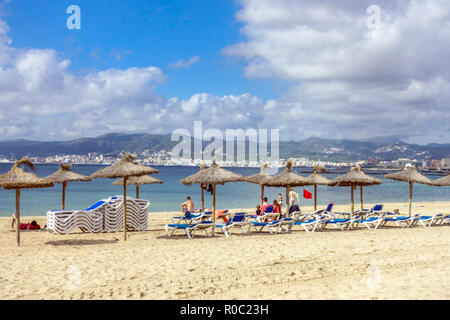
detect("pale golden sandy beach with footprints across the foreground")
[0,202,450,300]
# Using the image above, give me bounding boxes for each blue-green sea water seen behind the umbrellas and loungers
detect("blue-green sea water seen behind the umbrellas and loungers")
[0,163,450,217]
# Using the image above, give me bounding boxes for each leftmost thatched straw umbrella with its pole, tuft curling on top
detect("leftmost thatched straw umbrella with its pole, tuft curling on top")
[0,158,53,246]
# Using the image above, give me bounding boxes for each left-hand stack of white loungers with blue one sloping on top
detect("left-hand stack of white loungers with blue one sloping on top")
[47,199,107,234]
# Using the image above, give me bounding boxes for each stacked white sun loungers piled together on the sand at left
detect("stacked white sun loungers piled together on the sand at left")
[47,196,150,234]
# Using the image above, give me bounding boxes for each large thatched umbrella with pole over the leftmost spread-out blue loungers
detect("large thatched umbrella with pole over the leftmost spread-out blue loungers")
[180,160,244,236]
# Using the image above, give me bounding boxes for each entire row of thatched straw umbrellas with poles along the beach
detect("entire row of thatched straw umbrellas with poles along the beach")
[0,153,450,246]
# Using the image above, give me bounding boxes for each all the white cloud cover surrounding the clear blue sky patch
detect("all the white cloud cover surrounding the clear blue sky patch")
[0,0,450,143]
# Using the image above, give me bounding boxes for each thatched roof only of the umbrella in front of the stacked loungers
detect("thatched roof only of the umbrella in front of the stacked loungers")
[91,152,159,178]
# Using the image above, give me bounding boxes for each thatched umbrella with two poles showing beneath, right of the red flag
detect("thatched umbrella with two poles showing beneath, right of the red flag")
[329,166,382,214]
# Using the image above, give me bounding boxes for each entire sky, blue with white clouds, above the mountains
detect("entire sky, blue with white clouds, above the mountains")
[0,0,450,144]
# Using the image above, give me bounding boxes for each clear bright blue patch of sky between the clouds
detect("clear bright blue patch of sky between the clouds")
[5,0,283,99]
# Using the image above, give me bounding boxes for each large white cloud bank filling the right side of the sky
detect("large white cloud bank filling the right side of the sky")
[227,0,450,142]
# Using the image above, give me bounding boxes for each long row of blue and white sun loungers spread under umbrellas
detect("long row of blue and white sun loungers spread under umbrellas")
[165,203,450,239]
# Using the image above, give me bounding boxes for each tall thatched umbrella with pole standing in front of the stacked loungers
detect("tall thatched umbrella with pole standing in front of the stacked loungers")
[91,152,159,240]
